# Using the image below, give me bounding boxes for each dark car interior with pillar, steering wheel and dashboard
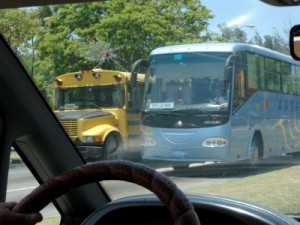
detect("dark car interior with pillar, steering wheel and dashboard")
[0,0,300,225]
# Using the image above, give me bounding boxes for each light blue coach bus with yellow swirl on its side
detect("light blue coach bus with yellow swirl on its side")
[133,43,300,169]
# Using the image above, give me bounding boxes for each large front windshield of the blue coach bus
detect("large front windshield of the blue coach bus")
[145,52,231,114]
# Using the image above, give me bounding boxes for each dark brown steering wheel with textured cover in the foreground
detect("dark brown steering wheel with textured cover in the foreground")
[13,160,200,225]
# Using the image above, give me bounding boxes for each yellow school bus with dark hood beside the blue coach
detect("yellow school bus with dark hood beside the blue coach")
[53,69,144,161]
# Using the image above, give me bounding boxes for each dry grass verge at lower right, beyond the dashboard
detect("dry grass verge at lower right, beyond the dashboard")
[185,166,300,213]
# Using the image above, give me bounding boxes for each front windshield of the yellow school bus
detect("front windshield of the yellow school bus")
[54,85,122,110]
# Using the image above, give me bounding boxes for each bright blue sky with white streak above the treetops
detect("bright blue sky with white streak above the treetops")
[201,0,300,38]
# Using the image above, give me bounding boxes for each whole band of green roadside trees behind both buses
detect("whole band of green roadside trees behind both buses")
[0,0,288,103]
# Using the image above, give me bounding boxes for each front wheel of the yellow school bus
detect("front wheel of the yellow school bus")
[103,134,122,160]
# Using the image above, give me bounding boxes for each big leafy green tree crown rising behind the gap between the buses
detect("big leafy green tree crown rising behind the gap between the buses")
[96,0,212,70]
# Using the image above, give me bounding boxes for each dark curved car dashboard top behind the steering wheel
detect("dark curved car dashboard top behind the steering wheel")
[83,195,299,225]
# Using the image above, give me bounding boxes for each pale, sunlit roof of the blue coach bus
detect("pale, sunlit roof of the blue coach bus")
[150,42,300,65]
